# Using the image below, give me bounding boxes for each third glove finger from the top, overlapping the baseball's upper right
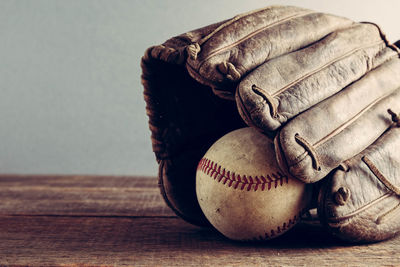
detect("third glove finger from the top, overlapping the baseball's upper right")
[275,58,400,182]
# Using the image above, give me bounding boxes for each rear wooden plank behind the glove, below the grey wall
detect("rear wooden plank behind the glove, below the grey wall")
[0,175,175,216]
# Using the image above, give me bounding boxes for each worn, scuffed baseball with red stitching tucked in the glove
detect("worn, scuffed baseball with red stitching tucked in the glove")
[196,128,311,243]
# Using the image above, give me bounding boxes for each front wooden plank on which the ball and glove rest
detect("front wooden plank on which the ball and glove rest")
[0,216,400,266]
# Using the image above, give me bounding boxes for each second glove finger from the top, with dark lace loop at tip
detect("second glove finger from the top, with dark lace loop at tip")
[236,23,397,132]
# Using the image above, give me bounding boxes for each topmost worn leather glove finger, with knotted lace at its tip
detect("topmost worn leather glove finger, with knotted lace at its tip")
[187,6,353,96]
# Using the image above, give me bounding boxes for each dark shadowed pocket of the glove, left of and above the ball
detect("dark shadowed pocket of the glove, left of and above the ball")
[141,39,245,225]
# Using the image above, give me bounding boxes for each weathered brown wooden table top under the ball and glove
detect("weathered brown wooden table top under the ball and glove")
[0,175,400,266]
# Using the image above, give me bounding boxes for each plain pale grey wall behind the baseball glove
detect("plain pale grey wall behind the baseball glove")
[0,0,400,176]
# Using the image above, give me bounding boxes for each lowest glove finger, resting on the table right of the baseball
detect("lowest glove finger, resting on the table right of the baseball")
[318,127,400,242]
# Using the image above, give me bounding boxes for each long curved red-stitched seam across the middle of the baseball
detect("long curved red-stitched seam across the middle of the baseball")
[197,158,289,191]
